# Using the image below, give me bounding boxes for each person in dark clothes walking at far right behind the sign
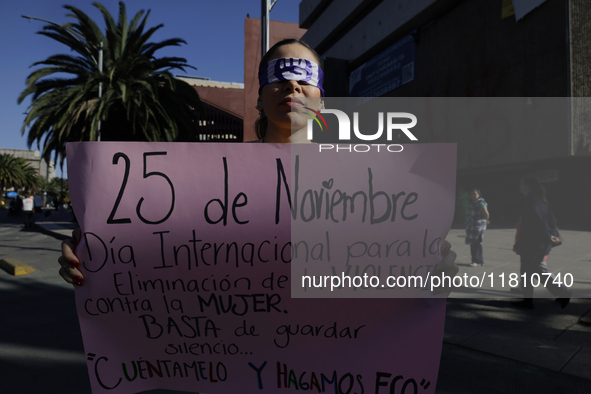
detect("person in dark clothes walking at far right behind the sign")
[512,175,571,309]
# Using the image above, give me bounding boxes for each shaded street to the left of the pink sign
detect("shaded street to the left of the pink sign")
[0,217,90,394]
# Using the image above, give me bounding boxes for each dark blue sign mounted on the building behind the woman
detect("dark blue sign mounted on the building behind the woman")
[349,34,415,97]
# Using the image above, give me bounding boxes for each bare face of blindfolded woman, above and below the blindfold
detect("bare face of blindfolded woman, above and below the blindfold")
[257,43,322,137]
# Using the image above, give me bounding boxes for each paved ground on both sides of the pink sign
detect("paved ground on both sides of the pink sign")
[0,208,591,394]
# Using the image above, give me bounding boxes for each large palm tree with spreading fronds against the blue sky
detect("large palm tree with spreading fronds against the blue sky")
[18,2,200,164]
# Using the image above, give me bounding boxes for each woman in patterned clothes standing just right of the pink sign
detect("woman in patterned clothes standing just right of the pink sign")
[466,189,490,267]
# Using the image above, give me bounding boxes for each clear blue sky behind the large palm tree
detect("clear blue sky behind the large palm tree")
[0,0,300,175]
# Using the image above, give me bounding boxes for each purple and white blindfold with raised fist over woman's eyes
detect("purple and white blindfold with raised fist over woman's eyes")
[259,57,324,96]
